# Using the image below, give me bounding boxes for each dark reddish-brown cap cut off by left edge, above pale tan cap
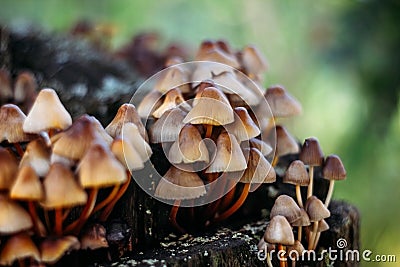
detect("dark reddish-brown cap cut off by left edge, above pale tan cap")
[0,147,18,190]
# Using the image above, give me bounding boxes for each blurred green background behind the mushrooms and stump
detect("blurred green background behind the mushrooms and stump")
[0,0,400,266]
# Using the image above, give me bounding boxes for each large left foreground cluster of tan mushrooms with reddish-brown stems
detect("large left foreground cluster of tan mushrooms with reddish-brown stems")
[0,85,152,266]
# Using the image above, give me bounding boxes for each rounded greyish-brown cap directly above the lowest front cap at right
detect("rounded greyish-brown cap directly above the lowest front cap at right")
[270,195,301,223]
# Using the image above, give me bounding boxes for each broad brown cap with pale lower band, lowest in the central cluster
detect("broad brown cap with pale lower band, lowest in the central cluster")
[154,166,206,200]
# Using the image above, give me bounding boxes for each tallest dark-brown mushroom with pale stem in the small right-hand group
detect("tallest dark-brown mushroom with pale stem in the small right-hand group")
[299,137,324,198]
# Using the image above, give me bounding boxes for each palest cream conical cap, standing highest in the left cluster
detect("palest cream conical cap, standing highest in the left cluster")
[23,89,72,133]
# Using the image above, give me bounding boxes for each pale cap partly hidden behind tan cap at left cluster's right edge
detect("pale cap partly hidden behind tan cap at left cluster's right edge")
[122,122,153,162]
